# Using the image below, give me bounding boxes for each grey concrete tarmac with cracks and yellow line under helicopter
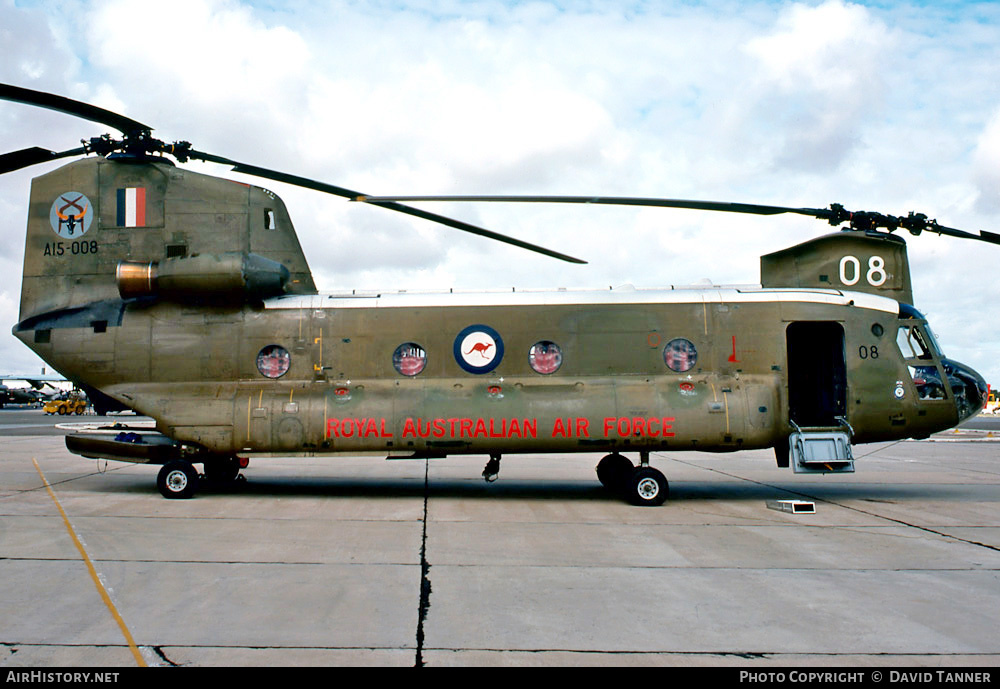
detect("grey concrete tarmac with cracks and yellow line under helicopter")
[0,410,1000,669]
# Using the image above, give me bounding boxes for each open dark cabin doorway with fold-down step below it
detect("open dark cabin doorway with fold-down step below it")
[785,321,854,473]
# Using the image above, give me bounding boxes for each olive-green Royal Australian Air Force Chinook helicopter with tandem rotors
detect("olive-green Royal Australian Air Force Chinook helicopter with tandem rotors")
[0,85,1000,505]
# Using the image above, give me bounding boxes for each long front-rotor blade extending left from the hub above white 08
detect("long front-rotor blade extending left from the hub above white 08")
[355,196,831,219]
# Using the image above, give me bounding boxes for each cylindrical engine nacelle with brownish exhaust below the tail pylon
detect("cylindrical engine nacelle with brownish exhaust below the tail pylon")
[115,252,290,301]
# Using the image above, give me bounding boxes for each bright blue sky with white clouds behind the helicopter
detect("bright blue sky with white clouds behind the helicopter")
[0,0,1000,385]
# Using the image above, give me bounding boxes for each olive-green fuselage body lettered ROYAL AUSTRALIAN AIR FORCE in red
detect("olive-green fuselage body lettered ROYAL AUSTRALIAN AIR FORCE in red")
[15,289,956,456]
